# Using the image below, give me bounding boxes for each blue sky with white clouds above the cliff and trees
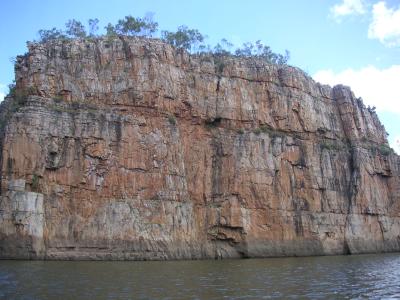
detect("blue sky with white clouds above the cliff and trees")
[0,0,400,153]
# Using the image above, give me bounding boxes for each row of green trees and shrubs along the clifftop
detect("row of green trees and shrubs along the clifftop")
[33,13,290,65]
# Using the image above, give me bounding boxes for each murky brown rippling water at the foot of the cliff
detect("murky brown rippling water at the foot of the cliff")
[0,254,400,299]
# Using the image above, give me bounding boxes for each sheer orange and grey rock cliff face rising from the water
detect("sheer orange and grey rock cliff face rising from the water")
[0,37,400,259]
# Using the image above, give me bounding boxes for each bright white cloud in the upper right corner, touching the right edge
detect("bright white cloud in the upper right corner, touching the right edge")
[368,1,400,47]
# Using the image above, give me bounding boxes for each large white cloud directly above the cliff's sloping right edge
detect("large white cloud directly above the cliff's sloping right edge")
[313,65,400,114]
